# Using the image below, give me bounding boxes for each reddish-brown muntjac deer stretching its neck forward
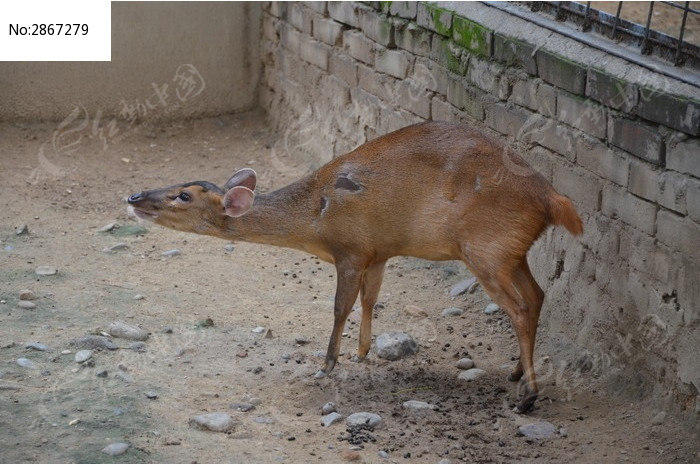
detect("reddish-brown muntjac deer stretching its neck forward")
[128,122,582,412]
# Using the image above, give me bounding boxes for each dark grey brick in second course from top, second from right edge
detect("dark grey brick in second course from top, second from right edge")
[608,115,665,165]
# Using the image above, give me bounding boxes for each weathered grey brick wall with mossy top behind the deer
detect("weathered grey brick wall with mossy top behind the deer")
[260,2,700,420]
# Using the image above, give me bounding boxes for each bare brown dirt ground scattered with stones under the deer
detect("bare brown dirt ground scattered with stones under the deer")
[0,113,700,463]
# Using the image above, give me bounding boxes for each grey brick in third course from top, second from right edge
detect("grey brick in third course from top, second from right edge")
[628,161,688,214]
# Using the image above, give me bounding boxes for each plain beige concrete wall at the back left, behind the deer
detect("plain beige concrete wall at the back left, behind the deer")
[0,2,260,121]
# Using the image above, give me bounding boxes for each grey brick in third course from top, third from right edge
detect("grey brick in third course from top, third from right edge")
[576,136,630,187]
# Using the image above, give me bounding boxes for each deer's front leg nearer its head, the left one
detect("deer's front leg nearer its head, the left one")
[316,263,363,378]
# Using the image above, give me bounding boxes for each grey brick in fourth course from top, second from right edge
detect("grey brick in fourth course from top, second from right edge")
[602,184,657,235]
